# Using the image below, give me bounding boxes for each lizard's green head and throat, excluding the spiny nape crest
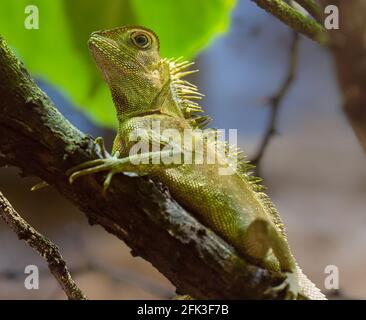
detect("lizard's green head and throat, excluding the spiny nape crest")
[89,26,174,119]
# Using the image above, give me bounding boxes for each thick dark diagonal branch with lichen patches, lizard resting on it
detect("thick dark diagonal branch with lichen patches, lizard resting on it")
[0,35,283,299]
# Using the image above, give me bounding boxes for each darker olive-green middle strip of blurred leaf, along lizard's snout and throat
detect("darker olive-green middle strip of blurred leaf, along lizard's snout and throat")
[64,0,136,127]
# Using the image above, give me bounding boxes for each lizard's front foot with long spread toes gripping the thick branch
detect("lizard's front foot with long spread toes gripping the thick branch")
[66,149,122,193]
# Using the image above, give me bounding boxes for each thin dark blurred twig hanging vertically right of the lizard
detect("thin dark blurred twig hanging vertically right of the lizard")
[252,31,299,175]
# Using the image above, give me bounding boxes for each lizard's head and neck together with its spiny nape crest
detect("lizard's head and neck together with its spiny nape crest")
[89,26,208,127]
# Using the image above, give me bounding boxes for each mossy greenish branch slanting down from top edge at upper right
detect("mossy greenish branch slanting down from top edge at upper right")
[252,0,327,44]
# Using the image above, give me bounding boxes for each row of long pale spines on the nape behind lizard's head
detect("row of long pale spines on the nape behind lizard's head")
[164,57,211,129]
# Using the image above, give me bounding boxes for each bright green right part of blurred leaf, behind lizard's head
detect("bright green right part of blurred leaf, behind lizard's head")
[131,0,236,59]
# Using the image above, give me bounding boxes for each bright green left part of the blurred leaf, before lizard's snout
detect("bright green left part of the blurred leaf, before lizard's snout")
[0,0,90,106]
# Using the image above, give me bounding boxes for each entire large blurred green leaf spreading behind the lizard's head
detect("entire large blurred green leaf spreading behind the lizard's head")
[0,0,236,127]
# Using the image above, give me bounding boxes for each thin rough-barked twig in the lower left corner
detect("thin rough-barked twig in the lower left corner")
[0,192,86,300]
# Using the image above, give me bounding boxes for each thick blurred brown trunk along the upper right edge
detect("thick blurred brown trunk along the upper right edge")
[321,0,366,151]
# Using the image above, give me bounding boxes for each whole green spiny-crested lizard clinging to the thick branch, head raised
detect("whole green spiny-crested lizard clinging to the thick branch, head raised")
[67,26,325,299]
